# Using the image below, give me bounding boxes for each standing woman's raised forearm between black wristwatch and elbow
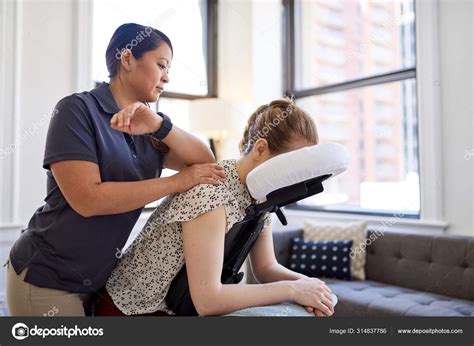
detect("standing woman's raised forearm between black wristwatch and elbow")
[163,126,216,166]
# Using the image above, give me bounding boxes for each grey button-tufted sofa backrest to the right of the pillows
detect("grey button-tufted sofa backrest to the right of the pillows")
[365,231,474,300]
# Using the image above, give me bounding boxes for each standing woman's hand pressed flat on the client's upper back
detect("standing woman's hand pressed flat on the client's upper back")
[172,163,225,192]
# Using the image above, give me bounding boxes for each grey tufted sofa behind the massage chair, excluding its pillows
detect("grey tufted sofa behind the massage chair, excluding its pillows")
[247,229,474,317]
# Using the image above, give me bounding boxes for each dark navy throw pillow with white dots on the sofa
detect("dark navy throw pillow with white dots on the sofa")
[287,238,352,280]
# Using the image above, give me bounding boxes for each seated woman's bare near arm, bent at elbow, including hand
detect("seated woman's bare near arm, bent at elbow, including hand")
[183,206,332,315]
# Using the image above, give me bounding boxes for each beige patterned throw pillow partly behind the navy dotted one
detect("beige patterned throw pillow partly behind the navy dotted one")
[303,222,367,280]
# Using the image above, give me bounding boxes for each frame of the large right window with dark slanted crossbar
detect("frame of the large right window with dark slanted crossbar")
[282,0,418,220]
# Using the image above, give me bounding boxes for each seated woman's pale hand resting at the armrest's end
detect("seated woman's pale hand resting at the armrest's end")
[293,277,334,316]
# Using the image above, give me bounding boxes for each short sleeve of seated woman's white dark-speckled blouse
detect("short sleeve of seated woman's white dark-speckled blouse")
[153,184,229,223]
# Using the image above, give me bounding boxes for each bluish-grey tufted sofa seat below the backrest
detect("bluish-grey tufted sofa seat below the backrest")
[323,279,474,316]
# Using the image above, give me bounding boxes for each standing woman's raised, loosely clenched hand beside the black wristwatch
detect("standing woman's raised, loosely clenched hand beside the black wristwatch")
[110,102,163,135]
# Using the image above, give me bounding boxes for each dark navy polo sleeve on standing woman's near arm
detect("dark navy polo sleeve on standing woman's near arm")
[43,95,98,170]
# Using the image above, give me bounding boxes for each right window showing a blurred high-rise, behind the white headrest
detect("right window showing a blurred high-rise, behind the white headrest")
[284,0,420,218]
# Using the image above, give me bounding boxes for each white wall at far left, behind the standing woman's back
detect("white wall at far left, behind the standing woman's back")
[0,0,76,309]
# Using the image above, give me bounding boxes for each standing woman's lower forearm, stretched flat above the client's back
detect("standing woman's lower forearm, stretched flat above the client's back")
[82,177,177,217]
